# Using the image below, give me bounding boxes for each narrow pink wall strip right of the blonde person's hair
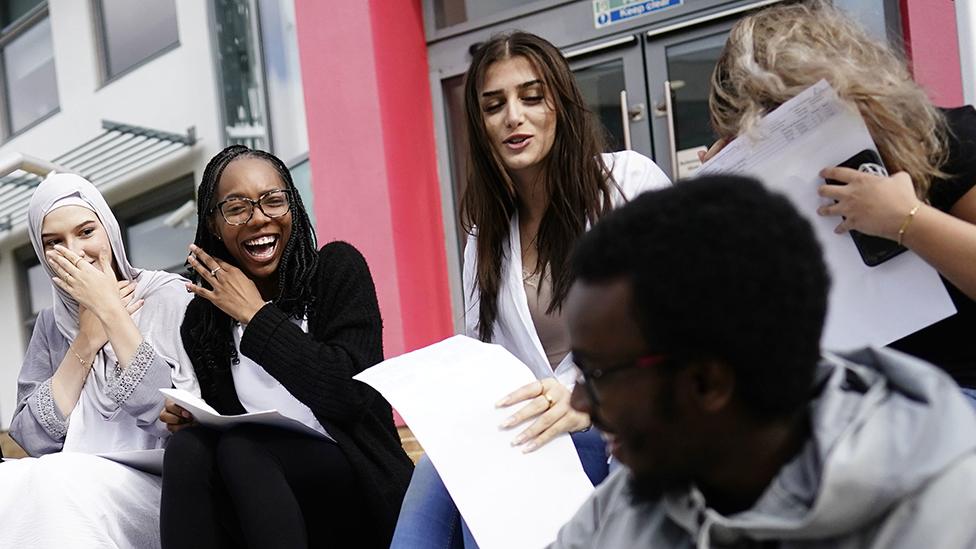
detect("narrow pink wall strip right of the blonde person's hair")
[901,0,971,107]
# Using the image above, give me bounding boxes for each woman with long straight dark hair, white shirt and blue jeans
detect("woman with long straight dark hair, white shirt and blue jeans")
[393,32,669,547]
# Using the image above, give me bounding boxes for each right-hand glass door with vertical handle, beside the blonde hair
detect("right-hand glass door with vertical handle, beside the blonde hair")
[646,21,733,181]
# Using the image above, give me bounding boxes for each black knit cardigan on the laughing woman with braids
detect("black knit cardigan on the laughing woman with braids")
[181,242,413,547]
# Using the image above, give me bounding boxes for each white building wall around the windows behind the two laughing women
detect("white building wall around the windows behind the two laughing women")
[0,0,222,430]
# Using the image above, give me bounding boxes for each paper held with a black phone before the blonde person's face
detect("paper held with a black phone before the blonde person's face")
[697,80,956,350]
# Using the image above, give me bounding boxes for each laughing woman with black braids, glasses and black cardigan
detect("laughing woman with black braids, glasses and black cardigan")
[160,145,412,548]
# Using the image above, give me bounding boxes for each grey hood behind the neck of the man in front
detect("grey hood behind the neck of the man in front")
[664,348,976,547]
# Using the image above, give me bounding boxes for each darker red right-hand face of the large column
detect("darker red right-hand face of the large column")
[370,0,454,351]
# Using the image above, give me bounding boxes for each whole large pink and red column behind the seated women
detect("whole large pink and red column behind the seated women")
[295,0,454,357]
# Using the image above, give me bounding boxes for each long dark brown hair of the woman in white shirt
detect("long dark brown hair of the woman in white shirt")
[461,31,613,341]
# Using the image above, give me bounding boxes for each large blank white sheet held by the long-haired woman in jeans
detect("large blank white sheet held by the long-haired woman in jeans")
[355,336,593,549]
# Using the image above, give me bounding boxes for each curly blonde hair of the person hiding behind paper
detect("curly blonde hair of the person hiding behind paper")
[708,1,948,199]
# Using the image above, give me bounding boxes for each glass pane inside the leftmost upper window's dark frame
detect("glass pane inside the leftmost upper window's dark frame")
[3,19,58,133]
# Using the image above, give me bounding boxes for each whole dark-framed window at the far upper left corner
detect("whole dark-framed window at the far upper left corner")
[0,0,59,138]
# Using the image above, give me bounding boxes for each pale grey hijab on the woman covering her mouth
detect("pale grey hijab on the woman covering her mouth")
[27,173,199,419]
